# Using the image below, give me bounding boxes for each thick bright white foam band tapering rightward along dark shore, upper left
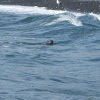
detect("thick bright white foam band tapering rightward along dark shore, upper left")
[0,5,65,15]
